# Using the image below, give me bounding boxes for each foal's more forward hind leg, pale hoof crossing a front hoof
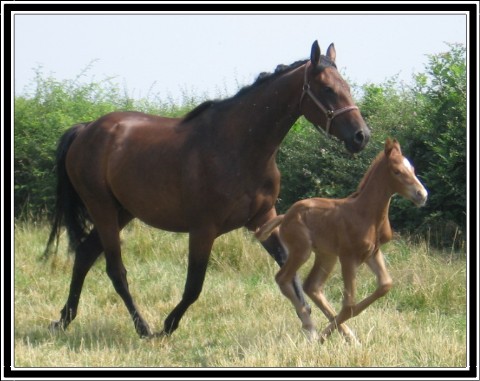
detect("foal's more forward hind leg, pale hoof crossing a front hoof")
[303,252,358,342]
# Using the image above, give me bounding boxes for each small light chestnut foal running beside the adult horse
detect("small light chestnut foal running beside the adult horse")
[256,139,427,341]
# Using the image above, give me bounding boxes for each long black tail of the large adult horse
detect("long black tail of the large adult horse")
[43,123,90,257]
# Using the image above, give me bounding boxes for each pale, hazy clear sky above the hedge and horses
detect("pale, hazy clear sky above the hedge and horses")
[14,13,467,101]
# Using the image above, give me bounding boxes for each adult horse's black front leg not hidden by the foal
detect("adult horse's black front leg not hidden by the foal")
[156,229,217,336]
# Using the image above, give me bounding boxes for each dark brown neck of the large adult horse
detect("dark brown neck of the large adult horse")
[220,65,304,163]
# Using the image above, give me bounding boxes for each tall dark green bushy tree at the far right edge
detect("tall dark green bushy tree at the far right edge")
[406,44,467,243]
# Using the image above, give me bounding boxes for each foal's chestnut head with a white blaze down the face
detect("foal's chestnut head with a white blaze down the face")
[385,139,428,207]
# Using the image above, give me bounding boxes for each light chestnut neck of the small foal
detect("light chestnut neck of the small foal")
[350,153,394,224]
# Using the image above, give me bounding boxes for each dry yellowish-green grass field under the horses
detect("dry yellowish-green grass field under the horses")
[14,223,467,367]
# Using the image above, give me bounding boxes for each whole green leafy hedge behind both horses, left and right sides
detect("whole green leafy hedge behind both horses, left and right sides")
[14,44,467,246]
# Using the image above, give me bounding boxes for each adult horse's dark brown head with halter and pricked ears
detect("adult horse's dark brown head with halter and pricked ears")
[300,41,370,153]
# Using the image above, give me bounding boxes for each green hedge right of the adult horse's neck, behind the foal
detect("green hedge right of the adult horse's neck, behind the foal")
[278,44,467,246]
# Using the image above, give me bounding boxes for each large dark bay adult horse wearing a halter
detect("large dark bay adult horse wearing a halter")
[46,41,370,337]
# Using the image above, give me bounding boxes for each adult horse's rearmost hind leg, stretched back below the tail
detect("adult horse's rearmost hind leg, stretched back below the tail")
[50,212,132,330]
